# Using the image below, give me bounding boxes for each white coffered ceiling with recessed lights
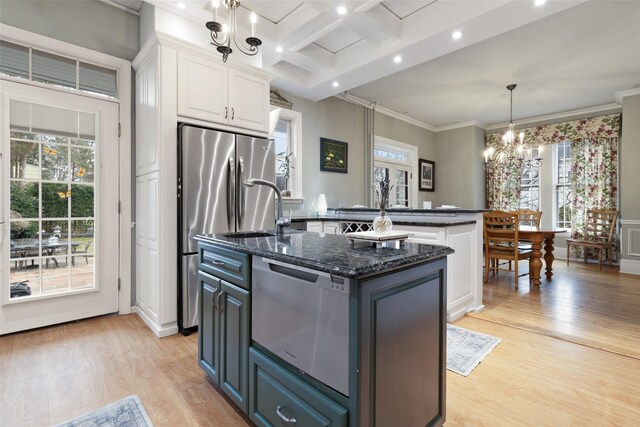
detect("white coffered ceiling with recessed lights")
[145,0,640,126]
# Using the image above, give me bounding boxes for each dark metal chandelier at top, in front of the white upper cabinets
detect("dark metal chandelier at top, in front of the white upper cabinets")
[205,0,262,62]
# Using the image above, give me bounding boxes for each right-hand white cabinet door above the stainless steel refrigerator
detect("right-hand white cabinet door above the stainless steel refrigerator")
[229,68,269,132]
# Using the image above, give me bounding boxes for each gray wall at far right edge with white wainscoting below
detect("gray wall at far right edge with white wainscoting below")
[619,95,640,261]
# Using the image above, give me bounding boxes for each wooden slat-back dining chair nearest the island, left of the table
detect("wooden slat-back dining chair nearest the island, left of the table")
[483,211,533,289]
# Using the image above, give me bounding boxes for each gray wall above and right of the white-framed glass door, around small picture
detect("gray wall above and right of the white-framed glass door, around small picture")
[373,113,439,208]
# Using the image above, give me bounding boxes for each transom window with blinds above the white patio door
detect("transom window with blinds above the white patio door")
[0,40,118,98]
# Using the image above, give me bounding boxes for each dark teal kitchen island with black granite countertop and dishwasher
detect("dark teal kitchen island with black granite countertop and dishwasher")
[197,232,453,427]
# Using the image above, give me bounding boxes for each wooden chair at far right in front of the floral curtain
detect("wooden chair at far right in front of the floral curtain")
[567,209,619,270]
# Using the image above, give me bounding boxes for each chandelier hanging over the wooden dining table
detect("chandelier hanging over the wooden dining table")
[484,84,542,169]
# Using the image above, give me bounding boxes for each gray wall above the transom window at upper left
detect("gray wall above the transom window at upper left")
[0,0,140,61]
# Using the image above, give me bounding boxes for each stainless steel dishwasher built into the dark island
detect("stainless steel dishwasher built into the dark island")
[251,257,350,396]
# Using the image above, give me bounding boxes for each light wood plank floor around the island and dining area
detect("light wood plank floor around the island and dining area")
[0,263,640,427]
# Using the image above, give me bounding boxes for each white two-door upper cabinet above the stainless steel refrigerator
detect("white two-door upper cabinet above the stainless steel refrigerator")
[178,52,269,133]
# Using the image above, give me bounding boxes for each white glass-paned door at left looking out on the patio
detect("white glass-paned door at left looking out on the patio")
[0,81,119,334]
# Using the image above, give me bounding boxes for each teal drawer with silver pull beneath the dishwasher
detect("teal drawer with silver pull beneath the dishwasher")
[249,348,348,427]
